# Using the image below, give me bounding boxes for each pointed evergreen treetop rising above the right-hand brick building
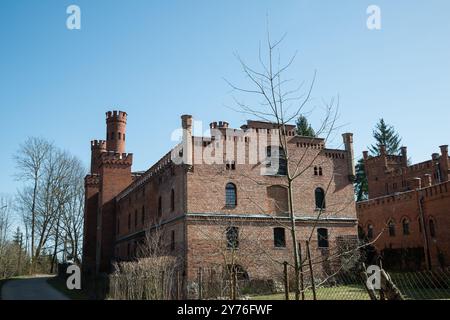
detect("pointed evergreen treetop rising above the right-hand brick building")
[369,118,402,156]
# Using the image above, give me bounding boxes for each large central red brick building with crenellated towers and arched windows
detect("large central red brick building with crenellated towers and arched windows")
[83,111,357,288]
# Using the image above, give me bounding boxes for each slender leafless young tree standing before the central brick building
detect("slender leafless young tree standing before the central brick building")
[227,28,339,299]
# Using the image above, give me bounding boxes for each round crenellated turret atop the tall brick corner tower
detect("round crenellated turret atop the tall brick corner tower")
[106,111,127,154]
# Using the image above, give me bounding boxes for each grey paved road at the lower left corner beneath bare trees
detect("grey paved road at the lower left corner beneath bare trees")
[1,276,69,300]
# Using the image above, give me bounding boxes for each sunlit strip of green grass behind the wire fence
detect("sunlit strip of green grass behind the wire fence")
[250,286,370,300]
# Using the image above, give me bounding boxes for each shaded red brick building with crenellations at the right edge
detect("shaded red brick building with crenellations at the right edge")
[357,145,450,270]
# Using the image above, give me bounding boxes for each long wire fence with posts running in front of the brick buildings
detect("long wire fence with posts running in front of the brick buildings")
[103,260,450,300]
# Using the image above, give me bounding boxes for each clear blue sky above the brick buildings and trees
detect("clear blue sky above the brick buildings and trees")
[0,0,450,198]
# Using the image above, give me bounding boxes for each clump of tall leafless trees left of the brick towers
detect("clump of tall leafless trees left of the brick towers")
[15,138,85,272]
